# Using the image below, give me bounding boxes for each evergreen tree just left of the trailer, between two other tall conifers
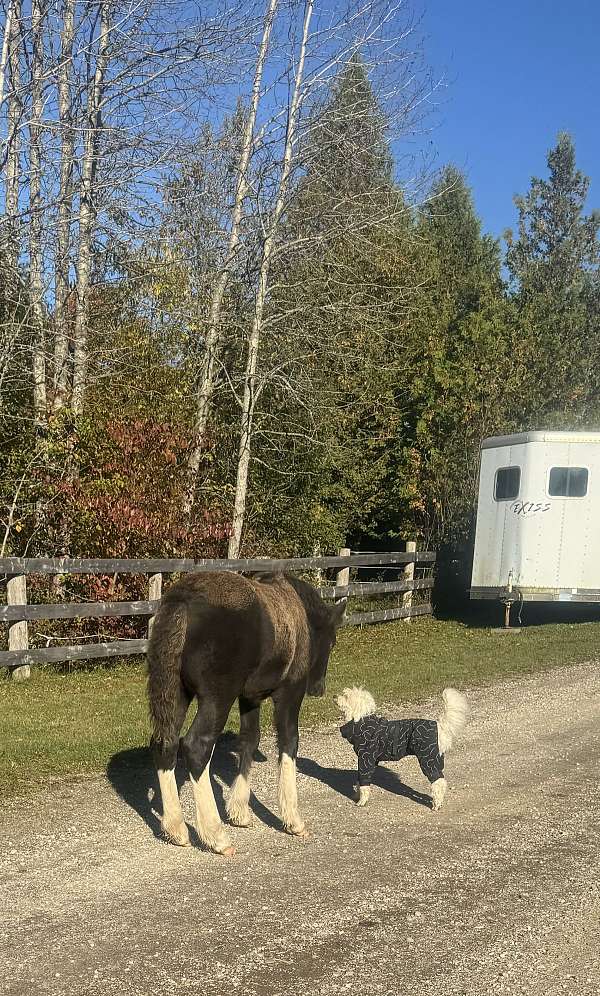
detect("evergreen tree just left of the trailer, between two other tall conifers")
[389,167,523,545]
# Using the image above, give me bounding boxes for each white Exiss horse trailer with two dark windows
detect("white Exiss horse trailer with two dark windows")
[470,432,600,624]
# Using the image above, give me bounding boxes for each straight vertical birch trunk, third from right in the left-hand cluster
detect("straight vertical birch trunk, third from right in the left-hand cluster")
[29,0,47,435]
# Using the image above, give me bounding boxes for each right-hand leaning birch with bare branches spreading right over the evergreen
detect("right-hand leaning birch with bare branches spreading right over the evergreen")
[223,2,431,556]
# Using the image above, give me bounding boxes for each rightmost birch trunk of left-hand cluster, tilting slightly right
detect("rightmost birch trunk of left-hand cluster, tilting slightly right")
[72,0,111,415]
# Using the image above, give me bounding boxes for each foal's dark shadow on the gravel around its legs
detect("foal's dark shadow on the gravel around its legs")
[106,733,281,844]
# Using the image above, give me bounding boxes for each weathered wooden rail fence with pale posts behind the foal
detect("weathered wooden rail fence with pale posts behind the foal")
[0,542,435,678]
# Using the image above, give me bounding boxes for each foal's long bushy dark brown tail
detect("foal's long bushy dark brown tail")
[148,600,187,751]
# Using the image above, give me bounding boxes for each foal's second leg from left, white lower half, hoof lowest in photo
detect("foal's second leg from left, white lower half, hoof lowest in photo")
[182,699,235,857]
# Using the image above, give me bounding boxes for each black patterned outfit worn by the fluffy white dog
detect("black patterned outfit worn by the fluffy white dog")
[340,715,444,785]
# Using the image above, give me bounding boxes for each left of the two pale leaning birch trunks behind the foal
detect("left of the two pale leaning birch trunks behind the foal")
[184,0,279,516]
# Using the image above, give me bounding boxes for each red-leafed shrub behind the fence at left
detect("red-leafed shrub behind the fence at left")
[55,418,229,558]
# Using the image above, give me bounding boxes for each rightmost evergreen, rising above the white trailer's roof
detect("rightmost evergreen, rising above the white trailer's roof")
[506,134,600,428]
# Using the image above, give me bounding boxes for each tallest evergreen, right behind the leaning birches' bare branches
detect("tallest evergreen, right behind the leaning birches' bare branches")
[265,56,410,539]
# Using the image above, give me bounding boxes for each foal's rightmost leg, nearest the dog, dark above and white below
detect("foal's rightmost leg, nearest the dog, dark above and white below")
[273,686,308,837]
